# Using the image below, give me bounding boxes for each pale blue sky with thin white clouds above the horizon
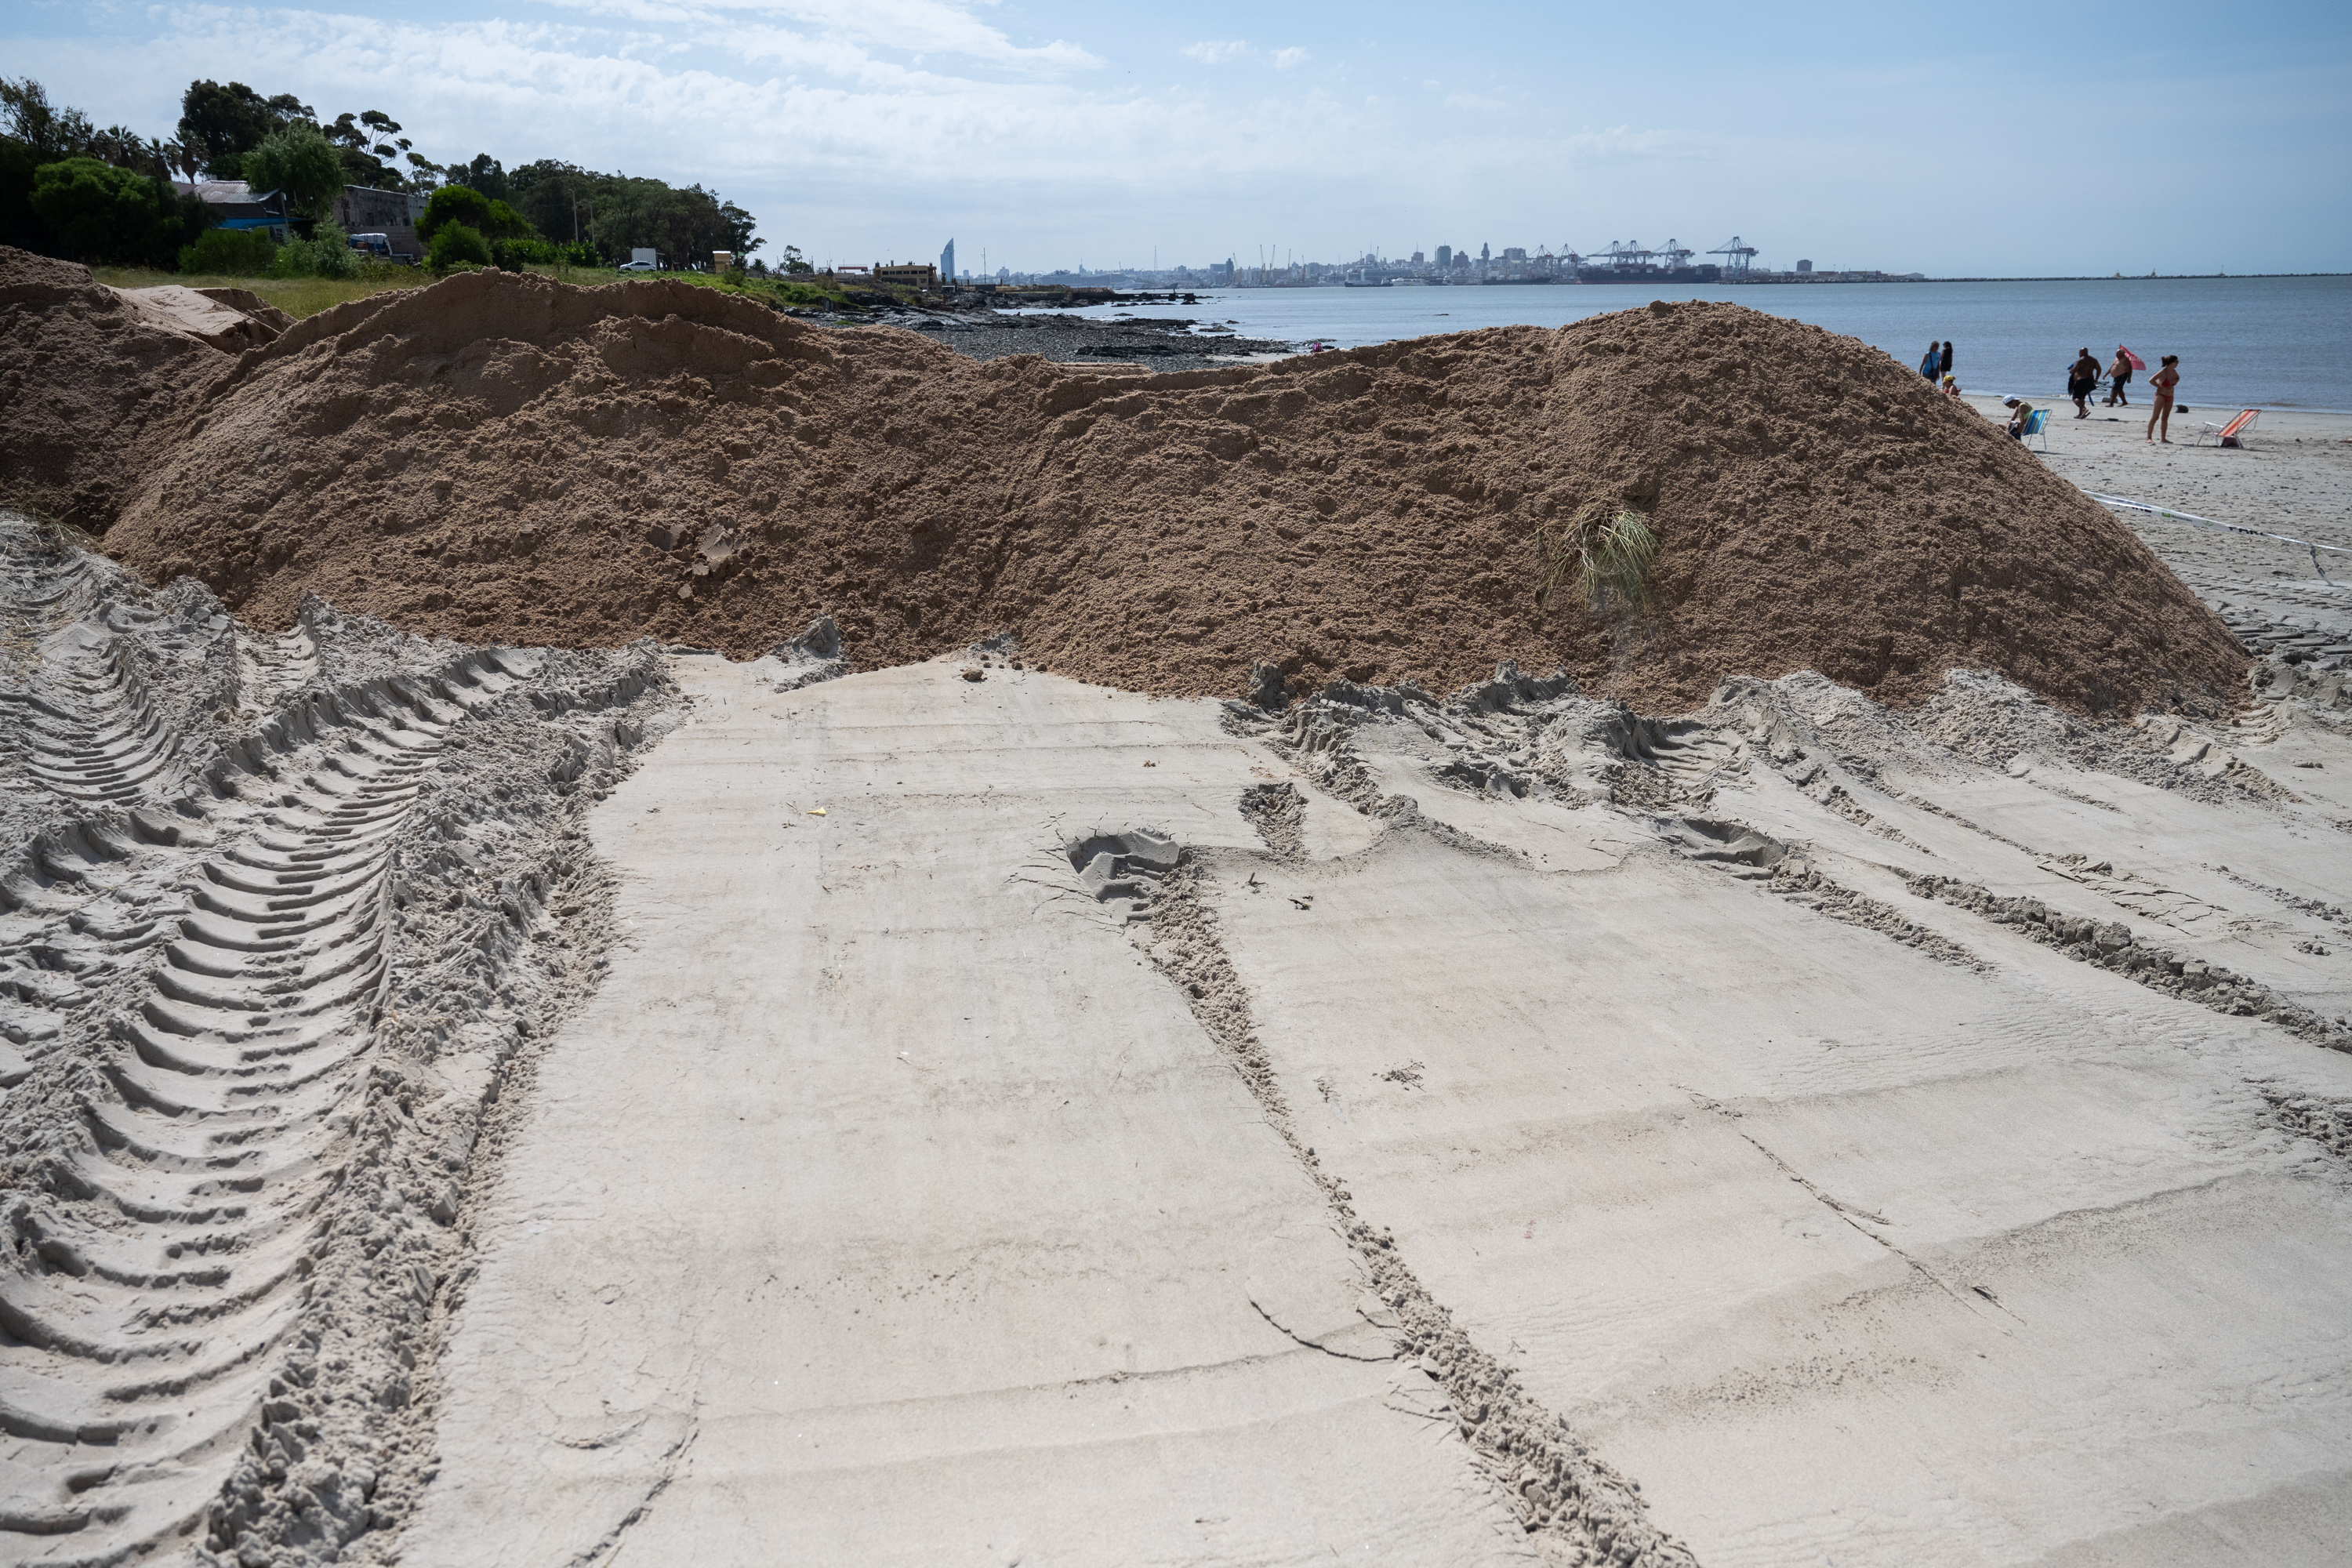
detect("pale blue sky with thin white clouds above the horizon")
[0,0,2352,278]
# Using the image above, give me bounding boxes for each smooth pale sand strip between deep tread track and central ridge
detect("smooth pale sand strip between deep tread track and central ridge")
[402,659,1534,1566]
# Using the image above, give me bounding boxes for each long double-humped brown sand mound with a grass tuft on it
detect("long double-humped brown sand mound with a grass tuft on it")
[41,255,2244,713]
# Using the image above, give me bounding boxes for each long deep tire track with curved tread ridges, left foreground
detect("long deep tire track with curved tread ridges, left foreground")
[0,654,529,1563]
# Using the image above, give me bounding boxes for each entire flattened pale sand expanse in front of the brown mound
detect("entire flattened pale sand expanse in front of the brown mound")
[407,659,2352,1568]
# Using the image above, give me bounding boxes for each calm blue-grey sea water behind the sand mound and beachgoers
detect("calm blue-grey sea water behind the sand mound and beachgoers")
[1058,278,2352,412]
